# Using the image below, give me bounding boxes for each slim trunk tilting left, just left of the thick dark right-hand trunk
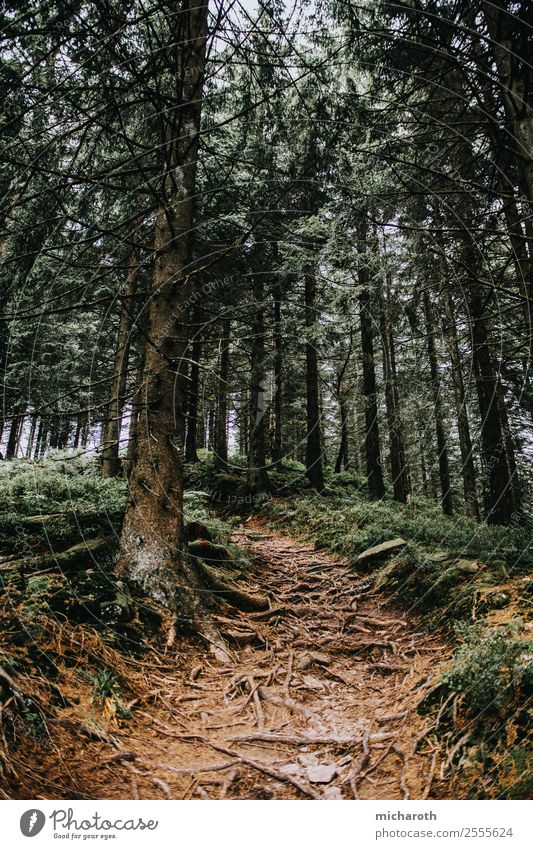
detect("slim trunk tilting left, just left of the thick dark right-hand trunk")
[443,281,480,522]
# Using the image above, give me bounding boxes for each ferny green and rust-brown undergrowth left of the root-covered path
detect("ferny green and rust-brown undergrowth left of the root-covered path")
[0,454,241,798]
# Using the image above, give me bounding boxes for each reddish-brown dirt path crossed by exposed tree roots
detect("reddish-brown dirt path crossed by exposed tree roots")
[83,525,446,799]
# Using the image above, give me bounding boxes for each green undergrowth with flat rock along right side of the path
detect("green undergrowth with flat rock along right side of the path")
[184,458,533,798]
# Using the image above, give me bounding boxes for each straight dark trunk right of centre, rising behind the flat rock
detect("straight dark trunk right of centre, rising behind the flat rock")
[357,213,385,500]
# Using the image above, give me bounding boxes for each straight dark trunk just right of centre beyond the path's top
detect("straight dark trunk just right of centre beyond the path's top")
[304,263,324,492]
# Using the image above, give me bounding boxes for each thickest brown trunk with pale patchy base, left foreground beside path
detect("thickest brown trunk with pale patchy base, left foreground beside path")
[118,0,228,660]
